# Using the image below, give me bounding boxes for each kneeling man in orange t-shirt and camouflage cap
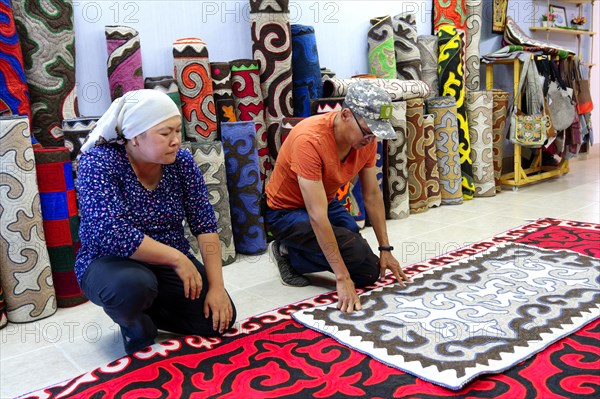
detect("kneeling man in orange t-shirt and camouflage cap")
[265,80,408,312]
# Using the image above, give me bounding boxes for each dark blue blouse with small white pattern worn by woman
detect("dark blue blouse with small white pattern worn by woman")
[75,144,217,282]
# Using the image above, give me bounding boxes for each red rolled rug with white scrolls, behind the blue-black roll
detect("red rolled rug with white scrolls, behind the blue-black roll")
[231,60,270,182]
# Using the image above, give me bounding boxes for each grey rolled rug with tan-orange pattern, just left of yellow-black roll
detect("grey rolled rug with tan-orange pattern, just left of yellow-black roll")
[427,96,463,205]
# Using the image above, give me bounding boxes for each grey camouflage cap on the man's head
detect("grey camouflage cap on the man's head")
[344,79,398,140]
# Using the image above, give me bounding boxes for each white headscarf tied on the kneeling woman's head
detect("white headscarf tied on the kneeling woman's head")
[81,89,181,153]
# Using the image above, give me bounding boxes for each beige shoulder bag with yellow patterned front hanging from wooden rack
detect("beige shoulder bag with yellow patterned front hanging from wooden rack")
[509,56,547,148]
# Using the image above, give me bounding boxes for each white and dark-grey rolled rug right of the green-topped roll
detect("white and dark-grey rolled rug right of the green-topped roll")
[392,12,421,80]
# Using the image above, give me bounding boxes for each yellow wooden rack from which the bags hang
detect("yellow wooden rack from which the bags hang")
[485,57,569,191]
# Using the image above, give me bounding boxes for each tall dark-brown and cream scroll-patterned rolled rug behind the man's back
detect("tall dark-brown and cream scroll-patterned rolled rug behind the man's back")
[250,0,294,174]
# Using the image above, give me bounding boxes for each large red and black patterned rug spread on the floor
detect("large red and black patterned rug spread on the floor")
[21,219,600,399]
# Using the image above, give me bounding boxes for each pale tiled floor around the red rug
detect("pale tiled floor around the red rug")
[0,146,600,398]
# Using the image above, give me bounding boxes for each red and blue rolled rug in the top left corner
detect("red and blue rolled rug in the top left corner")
[0,0,31,122]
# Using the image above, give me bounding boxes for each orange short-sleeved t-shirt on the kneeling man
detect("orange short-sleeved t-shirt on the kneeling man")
[265,112,377,209]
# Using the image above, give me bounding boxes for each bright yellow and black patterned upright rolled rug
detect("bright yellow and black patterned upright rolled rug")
[438,25,475,199]
